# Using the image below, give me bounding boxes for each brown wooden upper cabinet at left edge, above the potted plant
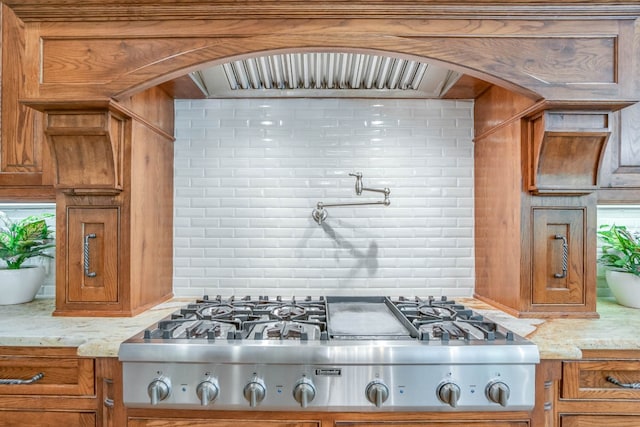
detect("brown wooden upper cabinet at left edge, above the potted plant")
[0,6,55,201]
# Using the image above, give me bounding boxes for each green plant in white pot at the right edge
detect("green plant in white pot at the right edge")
[598,224,640,308]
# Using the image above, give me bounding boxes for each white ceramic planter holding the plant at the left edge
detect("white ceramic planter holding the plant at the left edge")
[0,266,44,305]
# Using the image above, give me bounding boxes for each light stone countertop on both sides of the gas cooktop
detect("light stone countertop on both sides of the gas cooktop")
[0,298,640,359]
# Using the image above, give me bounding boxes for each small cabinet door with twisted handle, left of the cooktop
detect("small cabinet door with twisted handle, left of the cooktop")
[66,207,120,302]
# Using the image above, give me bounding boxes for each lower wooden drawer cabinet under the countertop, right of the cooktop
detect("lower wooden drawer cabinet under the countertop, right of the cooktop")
[556,350,640,427]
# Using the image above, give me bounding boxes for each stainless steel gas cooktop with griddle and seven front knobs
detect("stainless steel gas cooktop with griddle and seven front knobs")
[119,296,539,411]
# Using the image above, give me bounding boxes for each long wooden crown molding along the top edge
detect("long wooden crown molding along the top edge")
[4,0,640,22]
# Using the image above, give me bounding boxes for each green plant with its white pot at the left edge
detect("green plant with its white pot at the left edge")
[0,211,55,305]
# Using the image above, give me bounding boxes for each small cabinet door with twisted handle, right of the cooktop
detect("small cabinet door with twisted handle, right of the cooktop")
[531,208,586,305]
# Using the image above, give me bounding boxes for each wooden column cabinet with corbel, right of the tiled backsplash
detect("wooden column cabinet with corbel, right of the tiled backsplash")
[474,87,609,317]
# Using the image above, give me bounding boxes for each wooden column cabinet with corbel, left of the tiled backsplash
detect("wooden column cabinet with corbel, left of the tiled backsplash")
[31,88,173,316]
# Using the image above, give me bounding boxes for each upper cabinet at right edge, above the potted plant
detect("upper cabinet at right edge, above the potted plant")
[598,104,640,203]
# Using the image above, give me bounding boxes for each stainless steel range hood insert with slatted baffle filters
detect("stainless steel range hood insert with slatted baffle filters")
[190,52,460,98]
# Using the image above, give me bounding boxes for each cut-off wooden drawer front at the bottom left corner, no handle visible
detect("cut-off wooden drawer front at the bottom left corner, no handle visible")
[0,411,96,427]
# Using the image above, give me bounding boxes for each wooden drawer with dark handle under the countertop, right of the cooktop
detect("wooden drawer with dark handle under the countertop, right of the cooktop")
[562,359,640,402]
